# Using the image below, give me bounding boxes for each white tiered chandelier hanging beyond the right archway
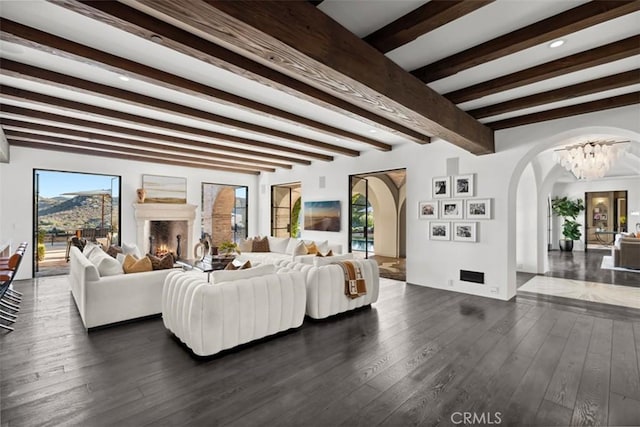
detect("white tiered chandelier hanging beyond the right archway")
[554,141,628,179]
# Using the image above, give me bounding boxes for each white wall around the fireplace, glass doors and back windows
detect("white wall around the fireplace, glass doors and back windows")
[0,147,258,279]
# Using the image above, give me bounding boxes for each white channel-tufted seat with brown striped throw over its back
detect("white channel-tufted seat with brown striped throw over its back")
[278,257,380,319]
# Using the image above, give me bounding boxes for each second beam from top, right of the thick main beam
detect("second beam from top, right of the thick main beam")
[411,0,640,83]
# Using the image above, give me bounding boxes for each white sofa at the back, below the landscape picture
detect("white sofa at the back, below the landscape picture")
[236,237,342,265]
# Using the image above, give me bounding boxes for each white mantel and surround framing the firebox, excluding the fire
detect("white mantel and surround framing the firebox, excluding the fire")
[133,203,197,254]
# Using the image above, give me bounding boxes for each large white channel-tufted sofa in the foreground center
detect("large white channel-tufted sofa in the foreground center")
[162,265,306,356]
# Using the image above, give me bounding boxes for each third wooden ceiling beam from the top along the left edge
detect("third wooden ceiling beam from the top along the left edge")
[0,85,322,165]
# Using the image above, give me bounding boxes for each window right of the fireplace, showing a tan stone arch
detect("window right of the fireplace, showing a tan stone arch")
[202,182,249,246]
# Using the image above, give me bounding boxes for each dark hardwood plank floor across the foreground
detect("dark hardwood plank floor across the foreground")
[0,277,640,427]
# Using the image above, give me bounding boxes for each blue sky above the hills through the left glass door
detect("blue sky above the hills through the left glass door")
[38,171,119,197]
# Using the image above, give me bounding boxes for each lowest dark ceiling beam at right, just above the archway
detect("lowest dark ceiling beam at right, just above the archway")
[487,92,640,130]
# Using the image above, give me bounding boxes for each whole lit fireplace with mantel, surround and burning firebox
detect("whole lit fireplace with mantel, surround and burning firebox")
[133,203,197,258]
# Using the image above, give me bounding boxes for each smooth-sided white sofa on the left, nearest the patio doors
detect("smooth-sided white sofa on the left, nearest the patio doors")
[69,246,178,329]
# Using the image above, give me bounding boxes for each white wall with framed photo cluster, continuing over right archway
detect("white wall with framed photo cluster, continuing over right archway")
[258,106,640,299]
